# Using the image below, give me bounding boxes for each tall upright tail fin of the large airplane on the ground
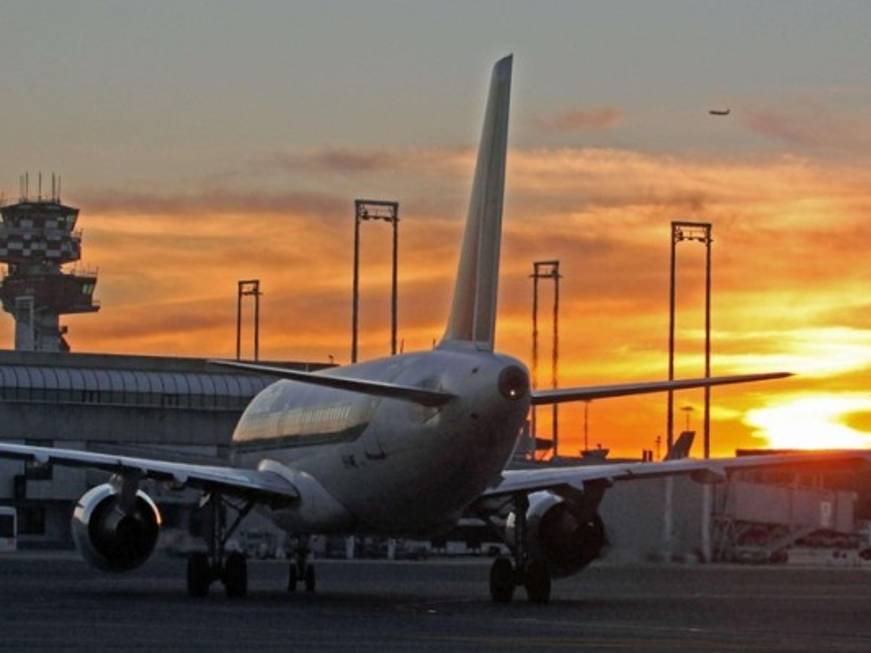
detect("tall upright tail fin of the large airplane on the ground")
[439,55,512,351]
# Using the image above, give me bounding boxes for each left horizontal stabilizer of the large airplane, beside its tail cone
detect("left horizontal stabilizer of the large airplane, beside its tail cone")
[209,360,455,407]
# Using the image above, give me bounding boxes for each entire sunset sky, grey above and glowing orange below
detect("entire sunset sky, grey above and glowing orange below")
[0,2,871,455]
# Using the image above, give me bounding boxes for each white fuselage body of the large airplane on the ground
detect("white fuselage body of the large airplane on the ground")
[233,343,529,535]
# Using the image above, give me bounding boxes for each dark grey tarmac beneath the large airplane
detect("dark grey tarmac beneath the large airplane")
[0,553,871,652]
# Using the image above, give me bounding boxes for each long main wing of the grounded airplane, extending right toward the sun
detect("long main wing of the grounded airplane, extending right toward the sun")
[478,450,871,501]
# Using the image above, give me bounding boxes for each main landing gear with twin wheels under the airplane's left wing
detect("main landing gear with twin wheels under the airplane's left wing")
[187,492,253,598]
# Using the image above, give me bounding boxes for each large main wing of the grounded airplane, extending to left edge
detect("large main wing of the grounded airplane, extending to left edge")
[0,442,299,500]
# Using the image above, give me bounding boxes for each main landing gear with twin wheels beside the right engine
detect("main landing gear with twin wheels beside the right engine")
[490,494,551,603]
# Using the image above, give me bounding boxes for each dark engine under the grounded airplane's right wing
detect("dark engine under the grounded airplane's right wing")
[508,492,605,578]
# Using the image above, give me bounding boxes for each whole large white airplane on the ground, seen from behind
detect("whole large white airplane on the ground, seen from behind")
[0,56,861,602]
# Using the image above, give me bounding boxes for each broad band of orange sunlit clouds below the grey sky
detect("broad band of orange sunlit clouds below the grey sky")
[22,143,871,453]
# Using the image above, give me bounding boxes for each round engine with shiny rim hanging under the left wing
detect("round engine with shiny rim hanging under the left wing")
[72,483,161,572]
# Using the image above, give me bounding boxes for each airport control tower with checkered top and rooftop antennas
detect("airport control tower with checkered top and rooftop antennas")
[0,177,100,352]
